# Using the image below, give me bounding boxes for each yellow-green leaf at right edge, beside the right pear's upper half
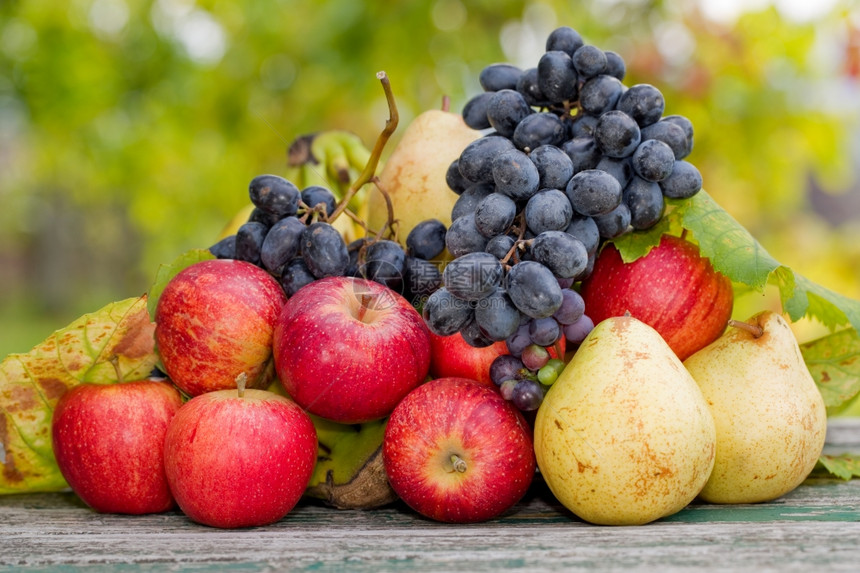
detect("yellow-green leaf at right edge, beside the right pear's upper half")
[800,328,860,408]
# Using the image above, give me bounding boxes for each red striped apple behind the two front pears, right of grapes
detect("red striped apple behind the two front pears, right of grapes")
[582,235,734,360]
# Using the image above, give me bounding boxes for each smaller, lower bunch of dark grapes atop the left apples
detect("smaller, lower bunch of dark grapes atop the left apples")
[209,175,447,304]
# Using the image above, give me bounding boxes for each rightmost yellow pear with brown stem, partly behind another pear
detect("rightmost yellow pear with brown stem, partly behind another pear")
[684,311,827,503]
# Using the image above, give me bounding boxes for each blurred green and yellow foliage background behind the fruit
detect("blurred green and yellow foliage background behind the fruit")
[0,0,860,356]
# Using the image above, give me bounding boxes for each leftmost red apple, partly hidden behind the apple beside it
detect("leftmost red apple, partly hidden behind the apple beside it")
[51,380,182,514]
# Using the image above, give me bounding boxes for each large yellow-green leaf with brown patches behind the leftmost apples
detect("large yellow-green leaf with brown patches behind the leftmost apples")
[0,296,156,494]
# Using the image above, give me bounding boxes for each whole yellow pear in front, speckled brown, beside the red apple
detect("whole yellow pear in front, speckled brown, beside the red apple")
[534,316,716,525]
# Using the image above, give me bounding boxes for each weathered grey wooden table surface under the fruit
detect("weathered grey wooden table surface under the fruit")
[0,419,860,573]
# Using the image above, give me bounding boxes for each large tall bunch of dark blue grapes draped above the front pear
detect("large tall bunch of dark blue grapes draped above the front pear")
[424,27,702,410]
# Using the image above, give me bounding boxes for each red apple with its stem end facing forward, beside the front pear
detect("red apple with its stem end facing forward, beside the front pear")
[382,378,535,523]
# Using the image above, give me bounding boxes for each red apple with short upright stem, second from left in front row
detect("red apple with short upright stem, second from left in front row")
[164,389,317,528]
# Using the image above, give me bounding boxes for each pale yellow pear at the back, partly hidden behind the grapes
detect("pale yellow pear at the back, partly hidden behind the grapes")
[367,110,481,244]
